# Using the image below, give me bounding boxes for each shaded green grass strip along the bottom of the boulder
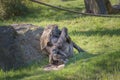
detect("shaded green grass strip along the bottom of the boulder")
[3,59,48,80]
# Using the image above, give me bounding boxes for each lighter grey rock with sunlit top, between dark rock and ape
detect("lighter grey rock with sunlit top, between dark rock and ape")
[12,24,43,63]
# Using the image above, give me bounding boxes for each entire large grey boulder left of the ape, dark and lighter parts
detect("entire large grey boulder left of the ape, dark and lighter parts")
[0,24,43,70]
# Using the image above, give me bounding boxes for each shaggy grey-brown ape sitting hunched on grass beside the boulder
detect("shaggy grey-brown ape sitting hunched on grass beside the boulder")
[40,25,81,65]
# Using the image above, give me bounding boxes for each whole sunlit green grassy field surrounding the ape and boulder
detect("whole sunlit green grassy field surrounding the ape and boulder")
[0,0,120,80]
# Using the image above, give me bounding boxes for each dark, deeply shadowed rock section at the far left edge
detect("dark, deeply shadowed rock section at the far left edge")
[0,26,23,70]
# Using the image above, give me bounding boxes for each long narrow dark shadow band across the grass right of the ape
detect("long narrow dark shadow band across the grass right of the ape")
[70,29,120,36]
